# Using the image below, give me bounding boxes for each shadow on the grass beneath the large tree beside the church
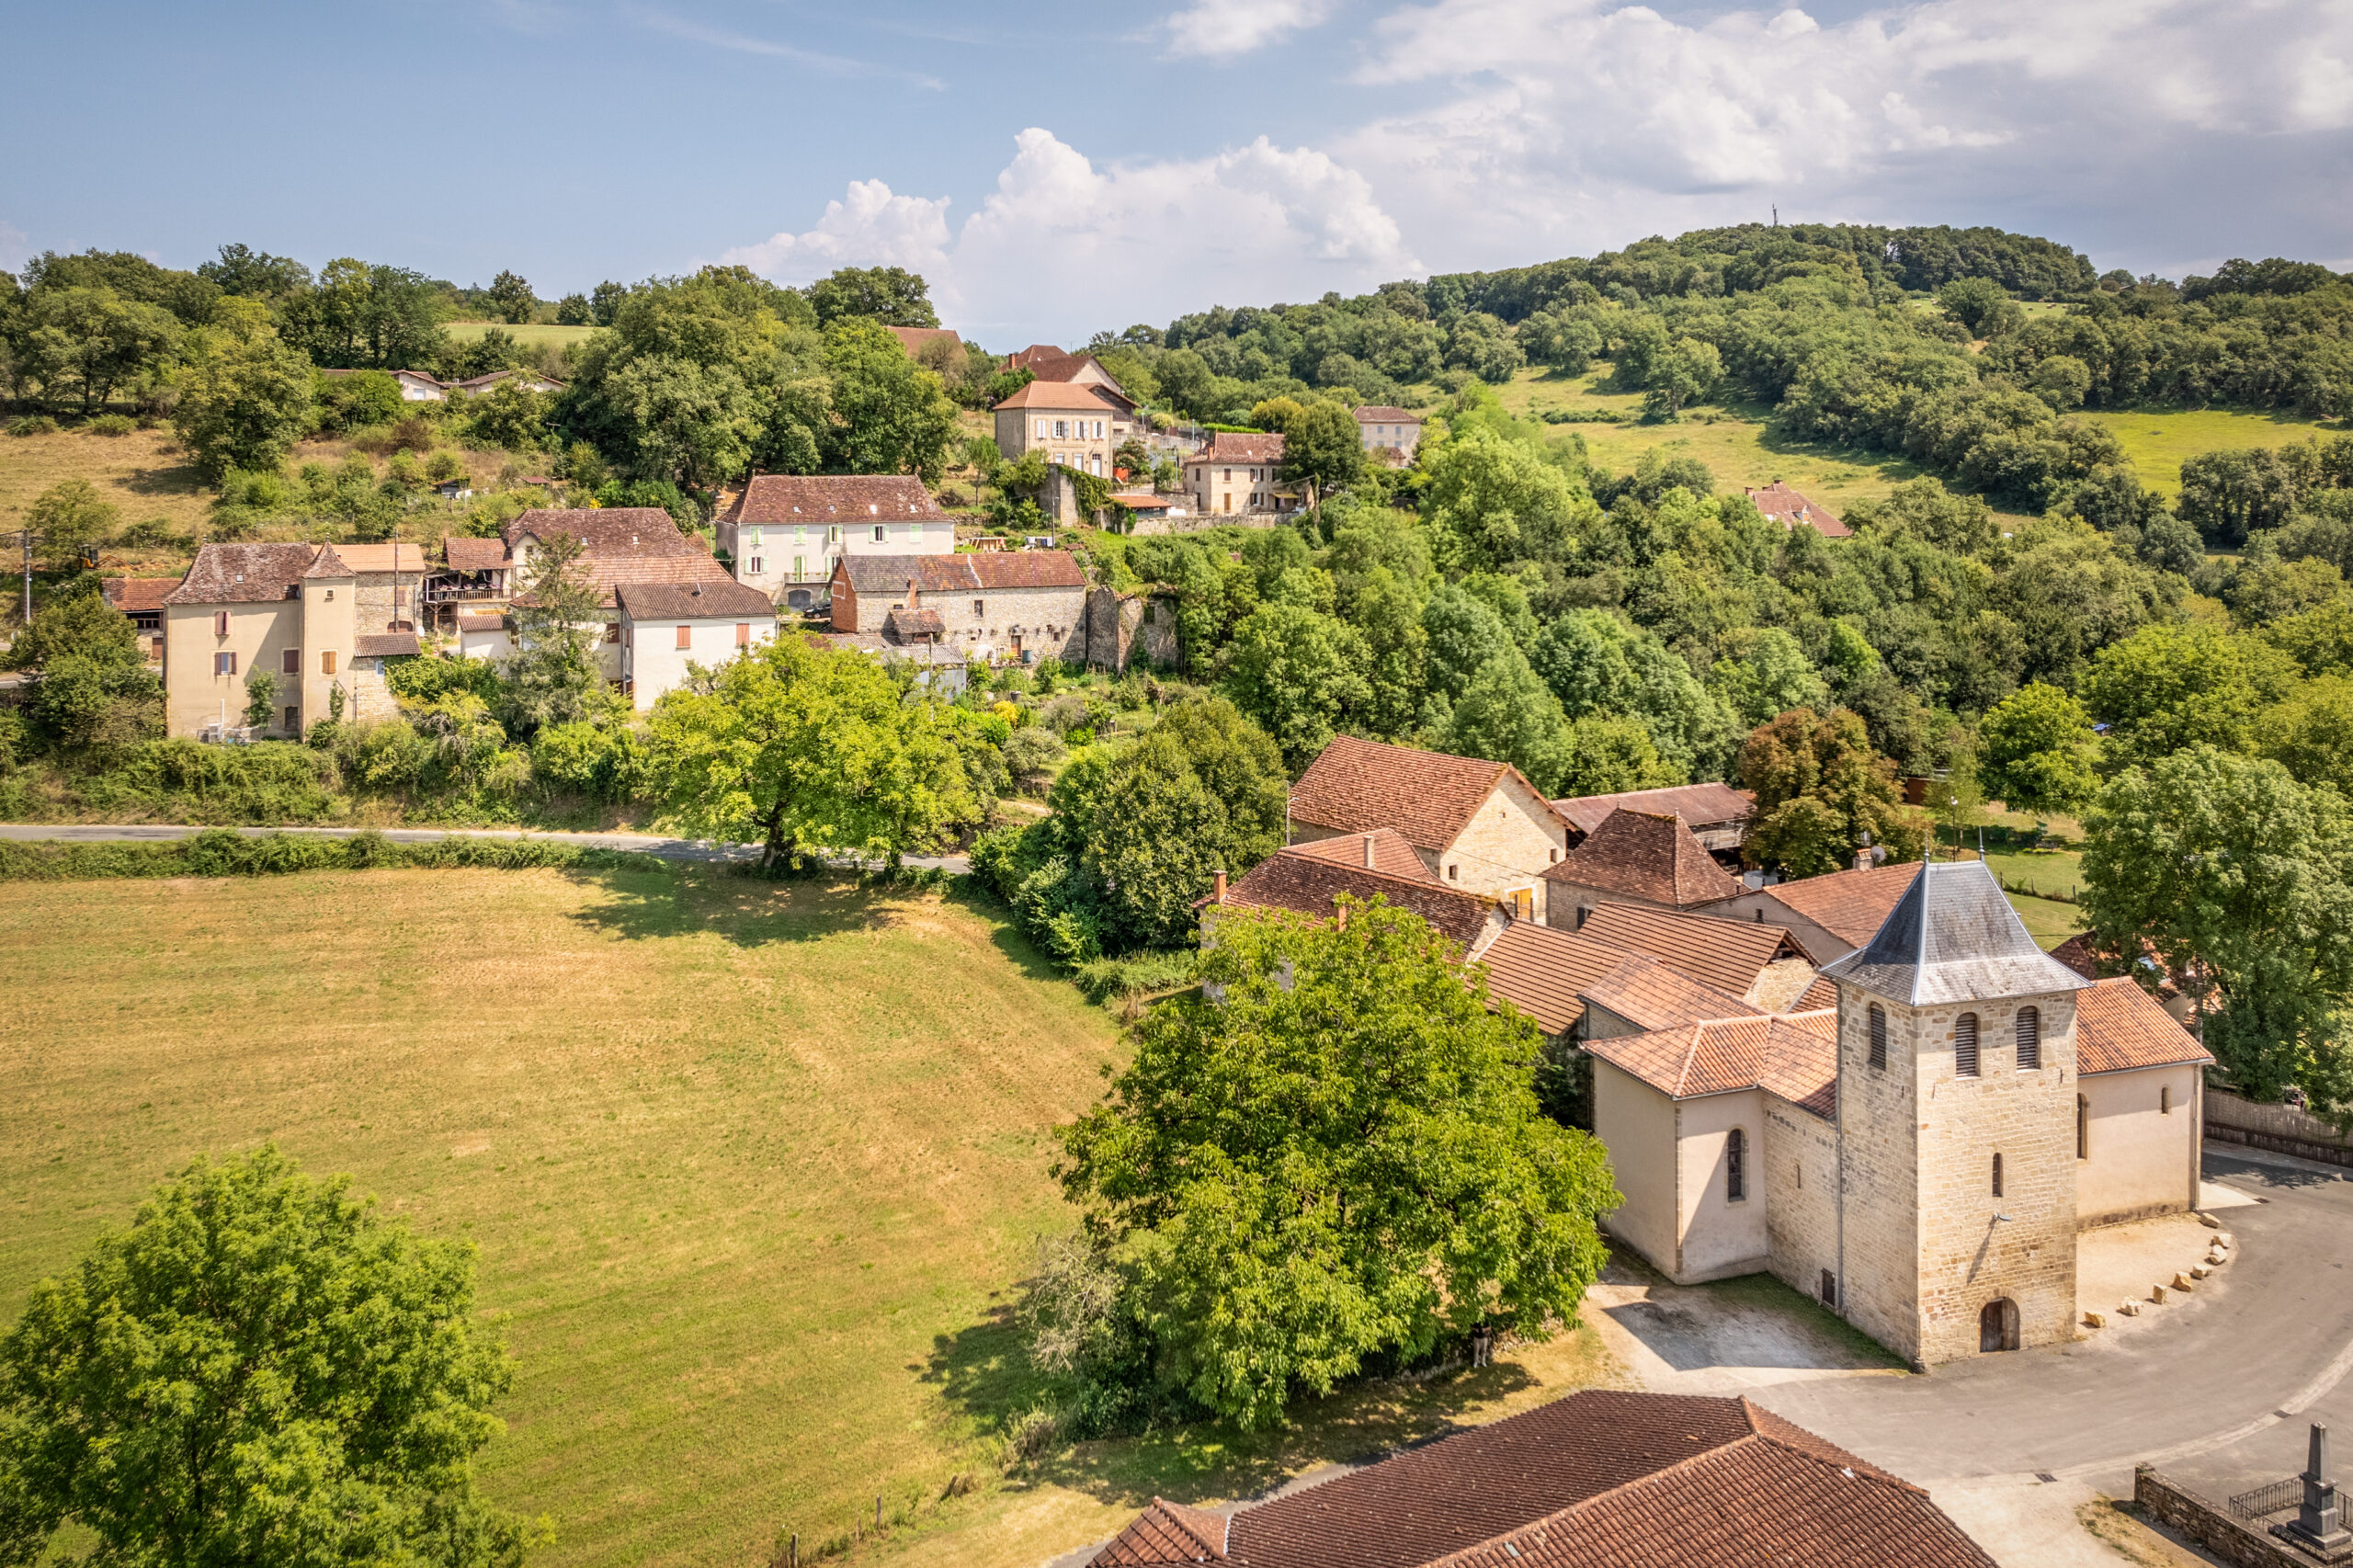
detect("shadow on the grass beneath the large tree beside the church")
[923,1307,1537,1509]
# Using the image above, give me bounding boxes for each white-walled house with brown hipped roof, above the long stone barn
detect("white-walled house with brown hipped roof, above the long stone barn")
[718,472,955,609]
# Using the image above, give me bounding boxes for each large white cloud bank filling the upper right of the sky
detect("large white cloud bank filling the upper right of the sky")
[1332,0,2353,266]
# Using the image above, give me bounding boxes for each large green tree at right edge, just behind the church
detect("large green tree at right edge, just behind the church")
[2083,746,2353,1114]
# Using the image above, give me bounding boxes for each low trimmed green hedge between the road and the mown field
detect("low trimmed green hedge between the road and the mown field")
[0,829,668,883]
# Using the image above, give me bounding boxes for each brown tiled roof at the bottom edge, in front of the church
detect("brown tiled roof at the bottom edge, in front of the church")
[1087,1389,1993,1568]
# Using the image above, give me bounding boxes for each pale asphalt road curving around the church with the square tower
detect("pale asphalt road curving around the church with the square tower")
[1751,1149,2353,1500]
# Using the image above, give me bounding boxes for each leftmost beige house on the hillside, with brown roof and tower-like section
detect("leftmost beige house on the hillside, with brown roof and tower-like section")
[163,544,416,739]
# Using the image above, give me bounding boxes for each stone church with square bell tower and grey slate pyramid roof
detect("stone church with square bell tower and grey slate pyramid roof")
[1586,862,2211,1366]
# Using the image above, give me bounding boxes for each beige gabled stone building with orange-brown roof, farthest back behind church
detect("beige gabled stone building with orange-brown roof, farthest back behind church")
[1287,734,1570,921]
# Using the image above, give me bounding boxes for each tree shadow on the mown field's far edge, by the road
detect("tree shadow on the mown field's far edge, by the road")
[572,864,908,947]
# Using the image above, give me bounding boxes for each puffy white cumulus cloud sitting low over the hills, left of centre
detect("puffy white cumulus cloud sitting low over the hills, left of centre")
[720,127,1419,347]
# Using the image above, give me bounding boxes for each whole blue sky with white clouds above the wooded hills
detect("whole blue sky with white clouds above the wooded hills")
[0,0,2353,348]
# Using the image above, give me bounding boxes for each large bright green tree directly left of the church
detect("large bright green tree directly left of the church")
[1062,902,1617,1426]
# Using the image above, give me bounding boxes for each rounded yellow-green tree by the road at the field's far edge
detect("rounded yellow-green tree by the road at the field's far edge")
[652,636,972,871]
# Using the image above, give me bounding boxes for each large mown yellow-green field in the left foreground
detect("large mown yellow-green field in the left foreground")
[0,871,1614,1568]
